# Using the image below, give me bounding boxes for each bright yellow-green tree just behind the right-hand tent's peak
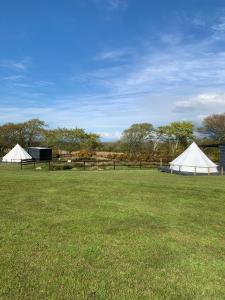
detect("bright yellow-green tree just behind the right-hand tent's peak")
[158,121,194,154]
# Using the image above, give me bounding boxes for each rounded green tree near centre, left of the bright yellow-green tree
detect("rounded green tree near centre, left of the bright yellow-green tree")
[121,123,154,156]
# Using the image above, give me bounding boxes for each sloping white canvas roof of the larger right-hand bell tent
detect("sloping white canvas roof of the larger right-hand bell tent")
[170,142,217,168]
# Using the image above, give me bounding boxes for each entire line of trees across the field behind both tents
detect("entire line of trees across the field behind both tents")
[0,113,225,160]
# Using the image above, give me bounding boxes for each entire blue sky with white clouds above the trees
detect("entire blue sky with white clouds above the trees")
[0,0,225,139]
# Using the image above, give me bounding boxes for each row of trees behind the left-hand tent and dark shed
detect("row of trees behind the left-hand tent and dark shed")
[0,119,100,154]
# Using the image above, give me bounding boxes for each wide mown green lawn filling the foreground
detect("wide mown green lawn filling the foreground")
[0,168,225,300]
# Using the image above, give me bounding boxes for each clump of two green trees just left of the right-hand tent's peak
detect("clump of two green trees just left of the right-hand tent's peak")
[118,122,194,160]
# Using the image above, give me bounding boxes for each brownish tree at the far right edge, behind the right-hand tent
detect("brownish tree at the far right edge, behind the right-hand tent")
[198,113,225,143]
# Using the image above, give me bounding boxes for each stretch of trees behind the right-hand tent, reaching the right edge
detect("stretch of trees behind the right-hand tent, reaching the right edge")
[120,113,225,159]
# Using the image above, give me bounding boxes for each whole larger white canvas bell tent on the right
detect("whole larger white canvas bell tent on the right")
[170,143,218,173]
